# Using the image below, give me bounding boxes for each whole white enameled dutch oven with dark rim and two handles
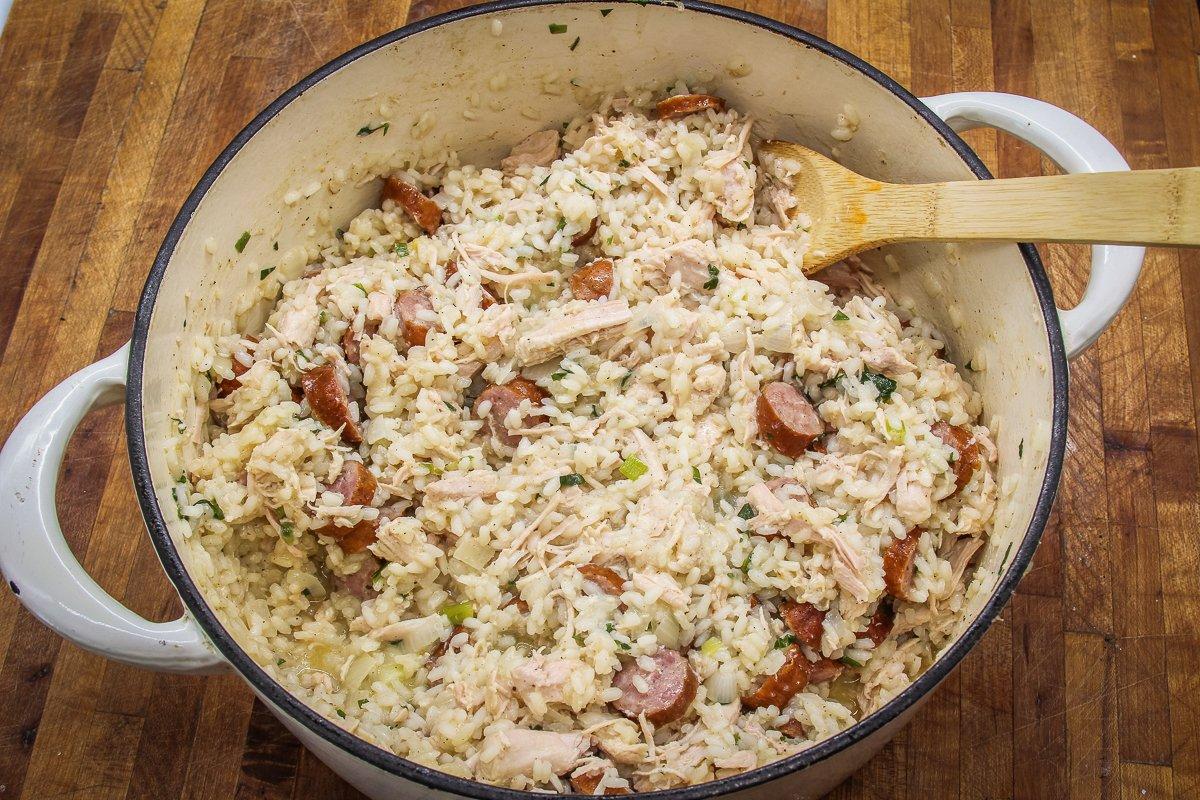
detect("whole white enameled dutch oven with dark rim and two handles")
[0,0,1142,800]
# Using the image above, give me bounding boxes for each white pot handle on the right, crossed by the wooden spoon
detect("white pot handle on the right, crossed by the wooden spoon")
[923,91,1146,359]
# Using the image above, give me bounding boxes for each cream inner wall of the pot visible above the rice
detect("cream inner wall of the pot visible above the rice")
[134,2,1054,767]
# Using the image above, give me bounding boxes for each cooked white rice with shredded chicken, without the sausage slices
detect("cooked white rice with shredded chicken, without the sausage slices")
[176,90,995,793]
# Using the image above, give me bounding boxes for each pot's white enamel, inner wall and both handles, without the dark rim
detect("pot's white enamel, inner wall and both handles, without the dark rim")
[0,2,1136,800]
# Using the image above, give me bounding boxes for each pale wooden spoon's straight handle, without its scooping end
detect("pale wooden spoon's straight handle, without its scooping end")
[864,167,1200,246]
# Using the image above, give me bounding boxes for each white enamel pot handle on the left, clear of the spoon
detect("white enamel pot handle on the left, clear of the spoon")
[0,344,226,673]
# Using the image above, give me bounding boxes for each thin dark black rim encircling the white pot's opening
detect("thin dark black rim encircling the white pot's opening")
[125,0,1068,800]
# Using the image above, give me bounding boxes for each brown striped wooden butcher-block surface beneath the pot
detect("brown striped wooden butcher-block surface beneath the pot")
[0,0,1200,800]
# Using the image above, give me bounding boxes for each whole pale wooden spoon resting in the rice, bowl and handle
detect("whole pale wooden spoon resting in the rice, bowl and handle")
[761,140,1200,275]
